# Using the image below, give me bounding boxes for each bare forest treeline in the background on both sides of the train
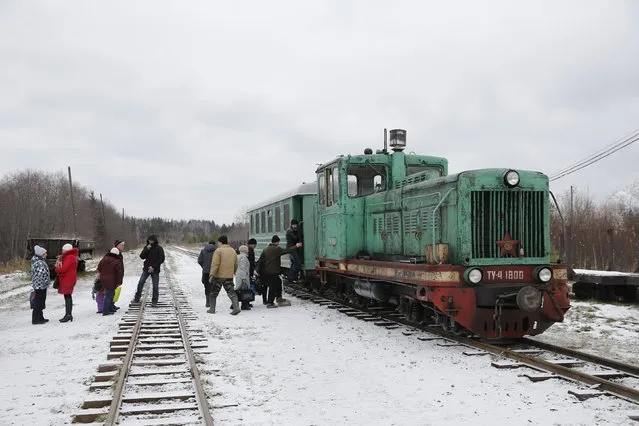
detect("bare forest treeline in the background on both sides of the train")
[0,170,639,271]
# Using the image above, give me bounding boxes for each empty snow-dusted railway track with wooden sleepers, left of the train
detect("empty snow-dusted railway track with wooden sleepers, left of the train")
[73,270,213,425]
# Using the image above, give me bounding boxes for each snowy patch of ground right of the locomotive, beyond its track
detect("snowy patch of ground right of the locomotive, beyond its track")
[534,300,639,365]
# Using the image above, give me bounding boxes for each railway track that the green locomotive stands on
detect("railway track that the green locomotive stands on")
[285,284,639,404]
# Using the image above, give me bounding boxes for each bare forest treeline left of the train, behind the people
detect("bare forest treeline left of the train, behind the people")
[0,170,247,263]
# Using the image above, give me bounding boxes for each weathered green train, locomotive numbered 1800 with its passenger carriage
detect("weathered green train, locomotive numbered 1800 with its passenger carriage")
[249,129,570,339]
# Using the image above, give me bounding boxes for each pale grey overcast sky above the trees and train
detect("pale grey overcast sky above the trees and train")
[0,0,639,222]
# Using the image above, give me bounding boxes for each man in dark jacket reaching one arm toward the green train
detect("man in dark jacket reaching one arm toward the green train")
[258,235,302,308]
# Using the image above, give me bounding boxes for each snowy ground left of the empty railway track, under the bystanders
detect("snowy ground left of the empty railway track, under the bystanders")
[0,252,141,426]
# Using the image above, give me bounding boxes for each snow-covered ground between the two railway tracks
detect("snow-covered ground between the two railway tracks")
[168,252,636,425]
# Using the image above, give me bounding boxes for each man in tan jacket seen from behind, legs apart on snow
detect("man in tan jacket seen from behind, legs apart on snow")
[207,235,241,315]
